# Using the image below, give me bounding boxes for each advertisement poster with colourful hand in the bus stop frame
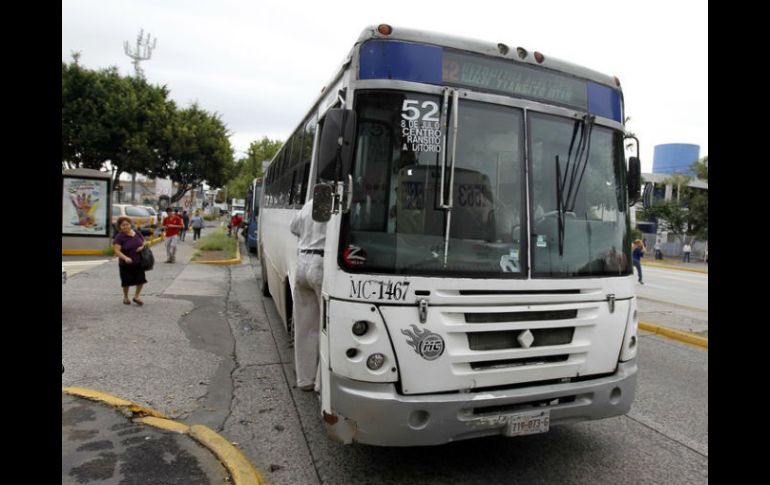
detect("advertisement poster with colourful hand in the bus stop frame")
[62,177,110,236]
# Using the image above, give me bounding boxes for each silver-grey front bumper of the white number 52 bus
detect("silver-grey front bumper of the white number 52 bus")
[324,359,637,446]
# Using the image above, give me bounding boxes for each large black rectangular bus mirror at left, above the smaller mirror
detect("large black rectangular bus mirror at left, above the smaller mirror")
[316,108,356,182]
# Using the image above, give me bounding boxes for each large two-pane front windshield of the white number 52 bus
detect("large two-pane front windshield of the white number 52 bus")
[340,91,630,278]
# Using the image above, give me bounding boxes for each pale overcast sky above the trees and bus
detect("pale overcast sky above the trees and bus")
[61,0,708,172]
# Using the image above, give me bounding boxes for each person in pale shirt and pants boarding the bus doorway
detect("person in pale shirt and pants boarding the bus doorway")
[289,199,326,391]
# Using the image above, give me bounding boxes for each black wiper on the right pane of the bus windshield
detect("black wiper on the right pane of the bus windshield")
[556,115,596,256]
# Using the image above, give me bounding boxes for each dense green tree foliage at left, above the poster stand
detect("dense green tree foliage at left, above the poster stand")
[61,56,234,199]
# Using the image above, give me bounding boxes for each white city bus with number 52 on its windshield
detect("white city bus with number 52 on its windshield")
[259,25,640,446]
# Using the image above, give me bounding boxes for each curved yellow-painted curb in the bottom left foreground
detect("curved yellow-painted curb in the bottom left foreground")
[62,387,265,485]
